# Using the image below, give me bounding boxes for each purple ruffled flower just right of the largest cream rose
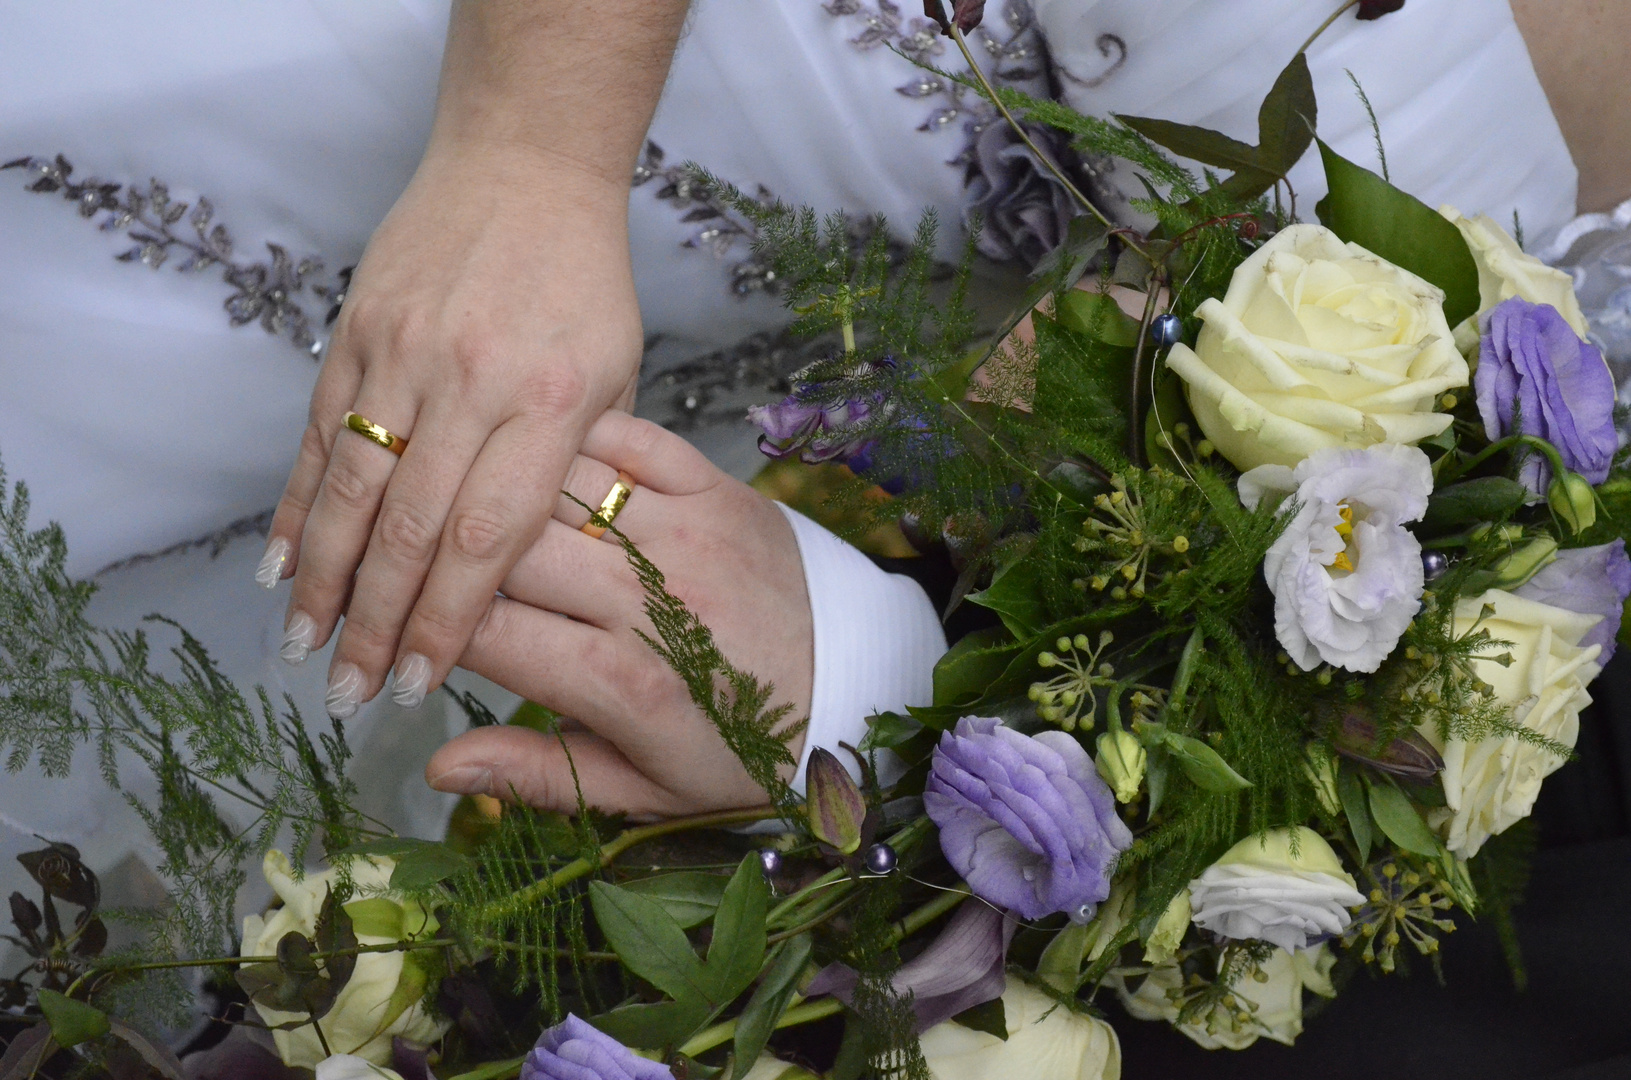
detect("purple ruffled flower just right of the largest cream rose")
[1473,297,1620,494]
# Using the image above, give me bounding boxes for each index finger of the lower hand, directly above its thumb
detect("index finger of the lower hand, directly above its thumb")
[458,597,693,750]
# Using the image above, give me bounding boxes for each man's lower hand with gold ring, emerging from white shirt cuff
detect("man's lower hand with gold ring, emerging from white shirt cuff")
[426,413,814,817]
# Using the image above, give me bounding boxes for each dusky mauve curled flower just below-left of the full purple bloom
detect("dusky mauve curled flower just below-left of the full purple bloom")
[804,901,1019,1033]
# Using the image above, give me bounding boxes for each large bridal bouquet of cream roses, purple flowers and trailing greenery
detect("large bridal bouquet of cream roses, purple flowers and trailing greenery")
[0,16,1631,1080]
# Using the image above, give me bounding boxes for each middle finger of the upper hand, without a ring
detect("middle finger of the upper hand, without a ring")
[329,405,484,719]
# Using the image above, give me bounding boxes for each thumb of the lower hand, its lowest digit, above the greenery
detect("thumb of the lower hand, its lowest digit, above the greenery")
[424,728,687,817]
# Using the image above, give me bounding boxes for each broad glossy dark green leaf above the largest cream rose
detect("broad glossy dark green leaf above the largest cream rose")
[1315,142,1478,326]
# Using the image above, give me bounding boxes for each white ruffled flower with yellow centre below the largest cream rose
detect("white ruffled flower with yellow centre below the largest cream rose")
[1240,444,1432,672]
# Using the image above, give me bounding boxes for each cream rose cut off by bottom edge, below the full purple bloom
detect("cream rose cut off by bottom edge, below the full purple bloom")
[922,979,1120,1080]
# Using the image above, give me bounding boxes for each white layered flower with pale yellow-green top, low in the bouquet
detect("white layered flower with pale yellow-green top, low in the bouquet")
[1189,825,1365,951]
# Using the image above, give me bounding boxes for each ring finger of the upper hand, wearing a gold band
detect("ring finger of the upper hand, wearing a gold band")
[282,385,416,678]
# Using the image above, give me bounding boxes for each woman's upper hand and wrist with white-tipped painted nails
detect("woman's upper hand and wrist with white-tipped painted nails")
[256,0,685,718]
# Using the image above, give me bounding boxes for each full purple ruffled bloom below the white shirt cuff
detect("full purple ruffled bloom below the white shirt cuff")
[923,716,1132,920]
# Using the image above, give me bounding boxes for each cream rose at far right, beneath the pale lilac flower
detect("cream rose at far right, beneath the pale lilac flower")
[1421,589,1602,858]
